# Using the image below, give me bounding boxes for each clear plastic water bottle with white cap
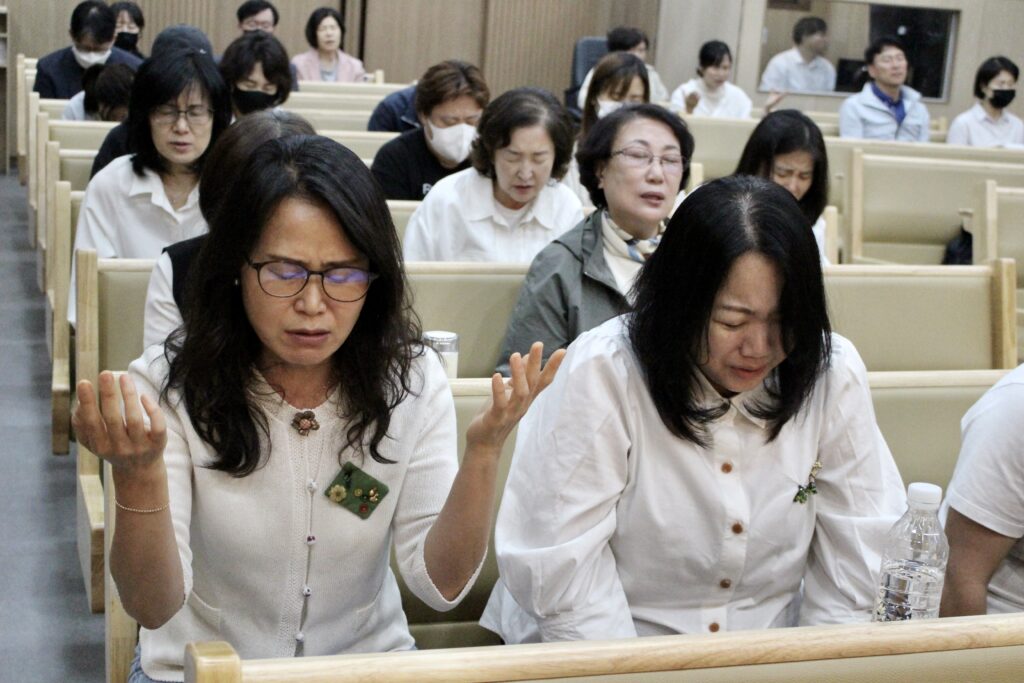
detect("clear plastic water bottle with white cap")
[874,482,949,622]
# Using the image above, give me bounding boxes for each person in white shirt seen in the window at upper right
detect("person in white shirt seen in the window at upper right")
[759,16,836,92]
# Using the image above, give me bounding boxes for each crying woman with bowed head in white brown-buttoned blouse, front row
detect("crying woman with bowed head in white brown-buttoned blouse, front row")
[481,174,906,643]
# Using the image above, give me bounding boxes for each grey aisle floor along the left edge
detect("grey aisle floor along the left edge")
[0,167,103,683]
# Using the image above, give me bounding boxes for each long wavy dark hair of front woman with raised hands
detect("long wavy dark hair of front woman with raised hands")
[163,135,422,477]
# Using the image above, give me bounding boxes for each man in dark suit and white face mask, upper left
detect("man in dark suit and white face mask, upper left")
[32,0,142,99]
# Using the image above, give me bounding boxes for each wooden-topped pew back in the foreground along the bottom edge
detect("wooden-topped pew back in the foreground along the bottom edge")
[185,614,1024,683]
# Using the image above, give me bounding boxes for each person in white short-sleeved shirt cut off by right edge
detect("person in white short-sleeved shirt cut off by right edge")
[941,366,1024,616]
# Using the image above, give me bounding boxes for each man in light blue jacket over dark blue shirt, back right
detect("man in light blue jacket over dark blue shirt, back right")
[839,37,931,142]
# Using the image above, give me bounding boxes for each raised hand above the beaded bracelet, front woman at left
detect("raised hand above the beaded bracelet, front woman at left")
[71,372,167,471]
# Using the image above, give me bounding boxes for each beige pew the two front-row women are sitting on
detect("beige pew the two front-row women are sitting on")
[105,371,1006,681]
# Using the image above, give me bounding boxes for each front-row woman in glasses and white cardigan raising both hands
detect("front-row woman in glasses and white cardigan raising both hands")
[73,135,560,681]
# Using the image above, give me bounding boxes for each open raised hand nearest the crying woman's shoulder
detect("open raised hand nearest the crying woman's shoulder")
[466,342,565,458]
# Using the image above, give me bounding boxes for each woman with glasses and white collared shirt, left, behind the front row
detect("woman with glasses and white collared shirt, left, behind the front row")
[68,48,231,324]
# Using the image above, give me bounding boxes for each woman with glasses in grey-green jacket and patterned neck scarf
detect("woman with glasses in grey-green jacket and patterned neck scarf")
[498,104,693,374]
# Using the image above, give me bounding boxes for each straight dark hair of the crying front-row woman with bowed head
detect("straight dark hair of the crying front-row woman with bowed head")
[629,175,831,445]
